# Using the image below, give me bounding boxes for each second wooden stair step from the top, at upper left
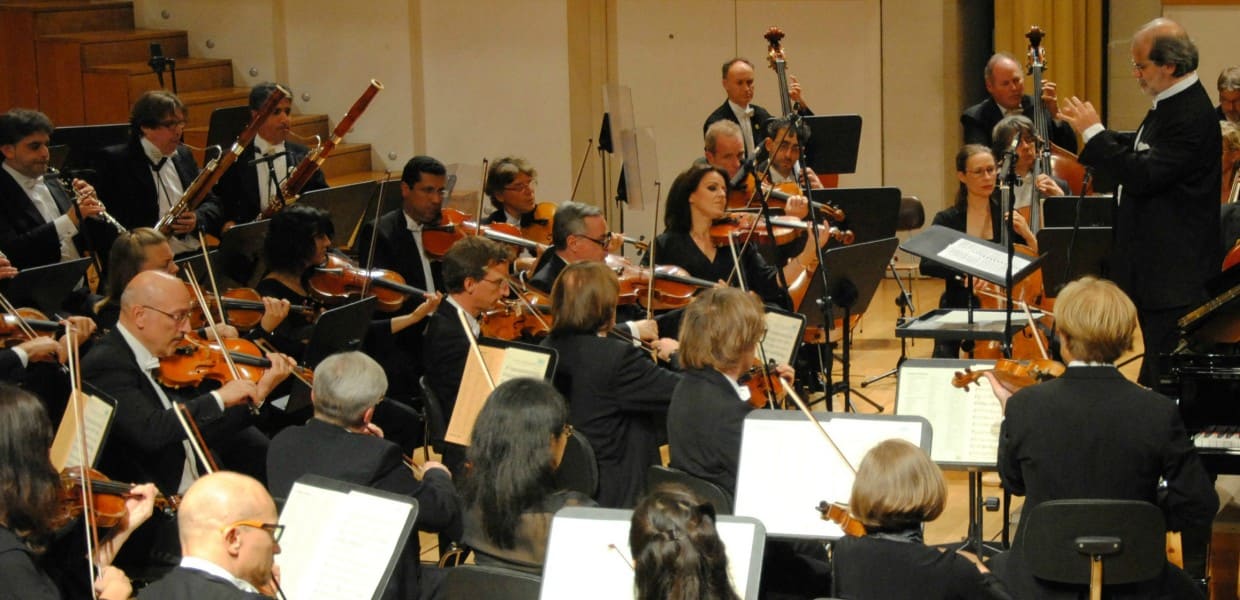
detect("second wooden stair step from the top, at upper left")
[36,30,188,125]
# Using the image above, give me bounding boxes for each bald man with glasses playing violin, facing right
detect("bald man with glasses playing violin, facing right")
[82,271,293,493]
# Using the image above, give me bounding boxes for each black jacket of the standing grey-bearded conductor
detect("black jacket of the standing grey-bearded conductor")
[1080,82,1223,310]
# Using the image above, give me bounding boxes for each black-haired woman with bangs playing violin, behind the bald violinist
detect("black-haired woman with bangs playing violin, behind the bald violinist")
[255,205,440,356]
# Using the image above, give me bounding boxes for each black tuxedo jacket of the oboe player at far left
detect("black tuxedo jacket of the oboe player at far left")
[0,163,117,269]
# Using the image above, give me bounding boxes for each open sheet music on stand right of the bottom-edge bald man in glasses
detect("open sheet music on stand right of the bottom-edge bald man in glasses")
[275,483,415,600]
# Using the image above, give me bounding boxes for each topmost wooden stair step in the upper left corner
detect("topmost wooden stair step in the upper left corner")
[0,0,134,107]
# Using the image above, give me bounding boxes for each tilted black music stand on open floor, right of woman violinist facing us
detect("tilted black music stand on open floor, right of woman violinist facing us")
[802,237,900,413]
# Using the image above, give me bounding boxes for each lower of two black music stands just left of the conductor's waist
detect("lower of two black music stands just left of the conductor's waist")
[1038,227,1114,298]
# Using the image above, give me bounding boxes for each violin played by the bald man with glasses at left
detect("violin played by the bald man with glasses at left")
[159,335,314,389]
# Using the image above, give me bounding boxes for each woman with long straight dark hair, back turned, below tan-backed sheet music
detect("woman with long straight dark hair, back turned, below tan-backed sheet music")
[460,378,594,573]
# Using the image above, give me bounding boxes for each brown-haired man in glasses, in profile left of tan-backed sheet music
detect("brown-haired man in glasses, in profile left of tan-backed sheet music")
[422,236,510,474]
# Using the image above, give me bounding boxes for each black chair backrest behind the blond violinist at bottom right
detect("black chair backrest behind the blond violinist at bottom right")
[1021,500,1167,585]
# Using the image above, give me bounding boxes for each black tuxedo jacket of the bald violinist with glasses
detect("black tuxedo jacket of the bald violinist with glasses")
[82,330,248,493]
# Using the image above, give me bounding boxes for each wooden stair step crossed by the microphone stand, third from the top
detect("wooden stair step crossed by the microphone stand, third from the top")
[82,57,233,123]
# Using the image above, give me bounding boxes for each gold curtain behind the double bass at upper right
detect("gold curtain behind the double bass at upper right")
[994,0,1106,105]
